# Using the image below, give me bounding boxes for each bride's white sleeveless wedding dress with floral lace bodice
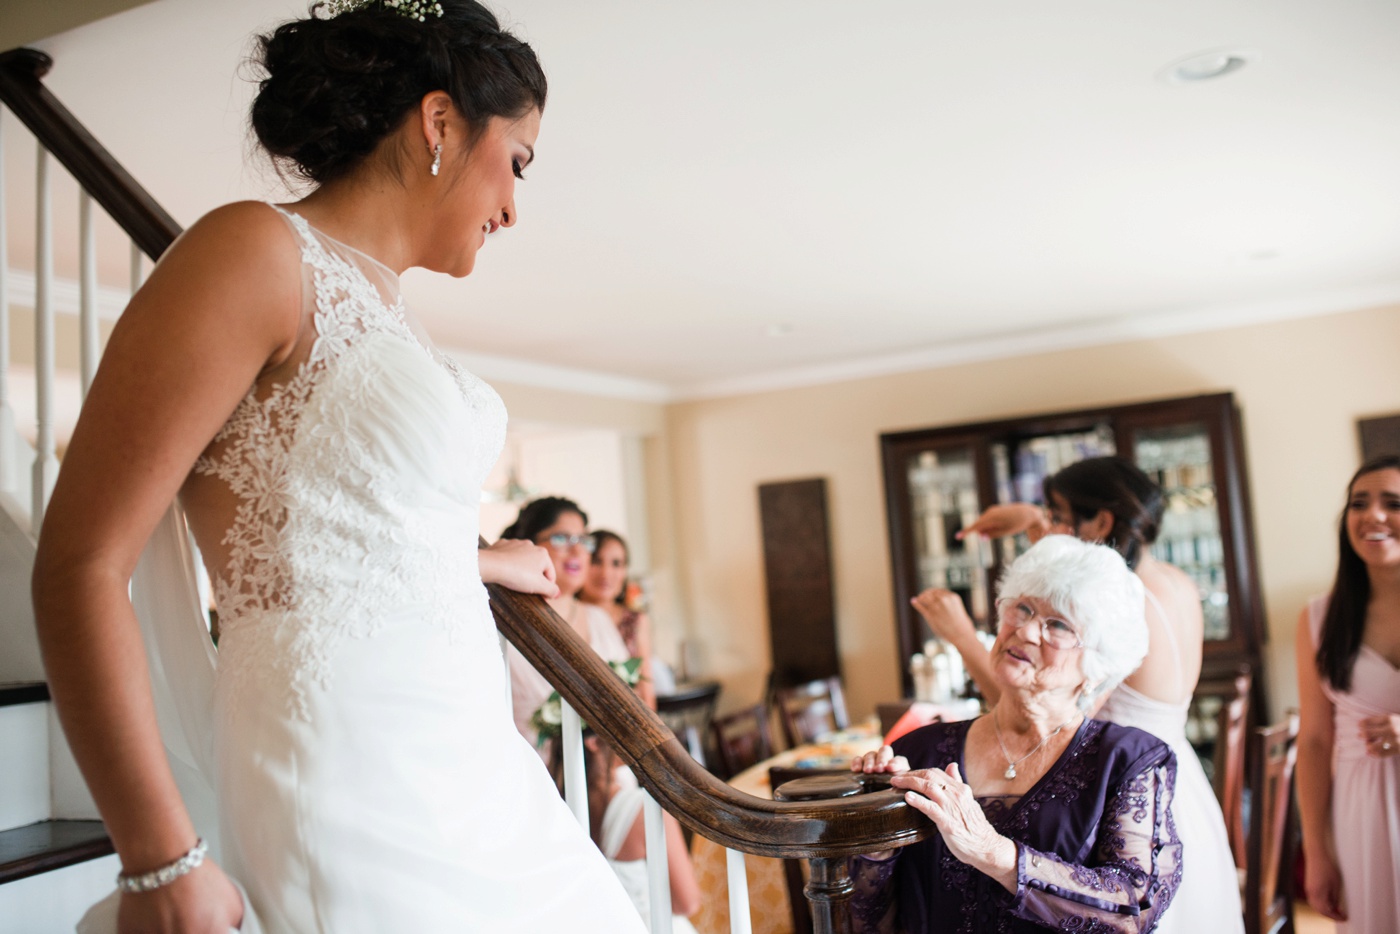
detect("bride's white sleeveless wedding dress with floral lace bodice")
[81,205,643,934]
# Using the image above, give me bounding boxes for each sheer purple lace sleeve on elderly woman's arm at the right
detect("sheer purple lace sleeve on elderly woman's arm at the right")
[1014,762,1182,934]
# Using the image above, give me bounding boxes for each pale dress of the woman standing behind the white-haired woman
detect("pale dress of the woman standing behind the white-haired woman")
[1095,591,1245,934]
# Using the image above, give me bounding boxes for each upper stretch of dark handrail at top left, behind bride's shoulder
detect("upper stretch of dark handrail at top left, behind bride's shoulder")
[0,49,181,259]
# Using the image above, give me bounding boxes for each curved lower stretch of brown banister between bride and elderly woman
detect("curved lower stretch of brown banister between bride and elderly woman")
[487,585,934,858]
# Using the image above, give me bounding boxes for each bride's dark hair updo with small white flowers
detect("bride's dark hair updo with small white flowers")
[251,0,546,185]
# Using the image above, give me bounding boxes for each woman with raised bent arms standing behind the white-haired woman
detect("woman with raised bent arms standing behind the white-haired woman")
[914,456,1245,934]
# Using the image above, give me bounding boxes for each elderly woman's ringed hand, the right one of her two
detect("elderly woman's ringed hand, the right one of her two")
[890,762,1016,892]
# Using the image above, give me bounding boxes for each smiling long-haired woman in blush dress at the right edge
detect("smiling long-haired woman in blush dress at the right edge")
[1298,456,1400,934]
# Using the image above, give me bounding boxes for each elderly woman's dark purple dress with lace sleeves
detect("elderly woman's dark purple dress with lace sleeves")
[851,720,1182,934]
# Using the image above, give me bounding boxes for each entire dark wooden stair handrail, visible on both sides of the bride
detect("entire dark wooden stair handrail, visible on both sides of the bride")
[0,42,934,858]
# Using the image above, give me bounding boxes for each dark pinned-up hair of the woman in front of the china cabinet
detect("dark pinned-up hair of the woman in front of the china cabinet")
[1044,456,1165,569]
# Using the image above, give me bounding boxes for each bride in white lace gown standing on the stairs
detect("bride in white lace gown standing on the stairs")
[34,0,641,934]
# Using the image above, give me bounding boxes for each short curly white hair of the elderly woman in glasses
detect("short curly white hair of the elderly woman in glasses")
[997,535,1147,707]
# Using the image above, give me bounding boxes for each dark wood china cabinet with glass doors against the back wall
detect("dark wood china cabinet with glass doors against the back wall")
[881,392,1266,761]
